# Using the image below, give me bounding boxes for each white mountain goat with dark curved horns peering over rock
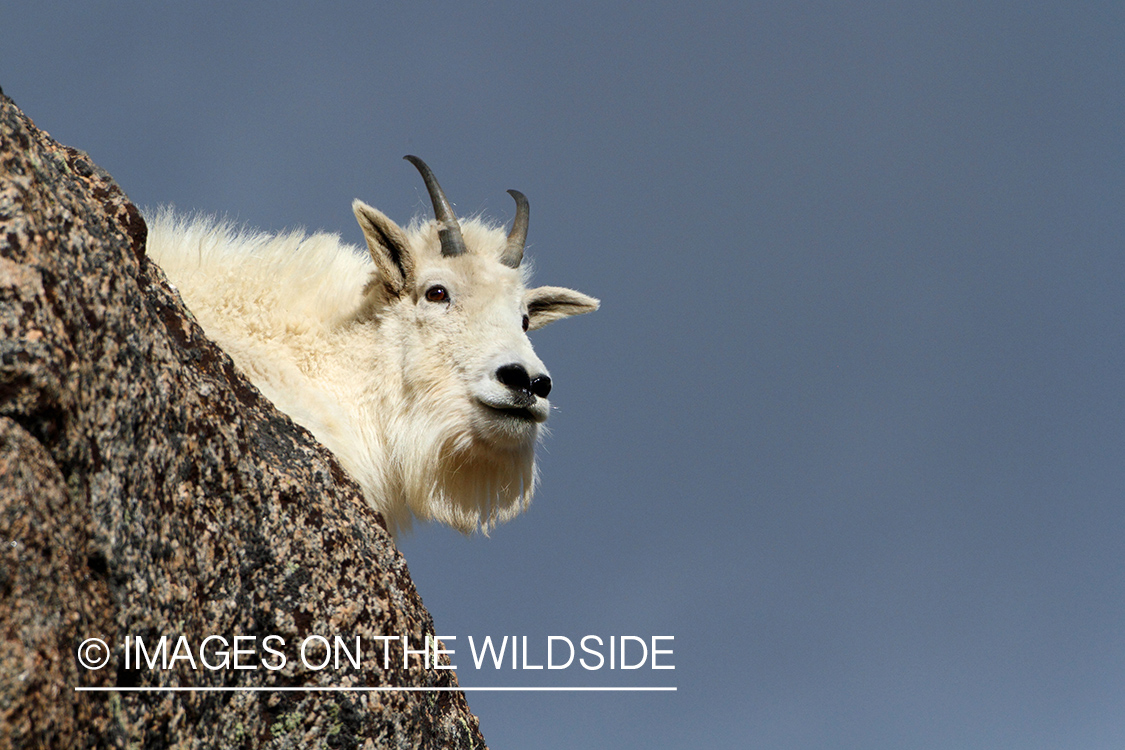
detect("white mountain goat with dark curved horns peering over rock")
[147,156,599,534]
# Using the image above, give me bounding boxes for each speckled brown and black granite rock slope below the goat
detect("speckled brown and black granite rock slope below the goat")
[0,93,484,748]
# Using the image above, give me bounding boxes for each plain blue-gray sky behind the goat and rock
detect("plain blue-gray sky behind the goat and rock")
[0,0,1125,750]
